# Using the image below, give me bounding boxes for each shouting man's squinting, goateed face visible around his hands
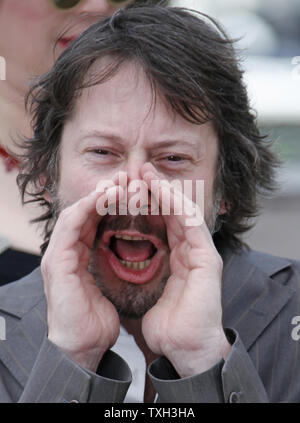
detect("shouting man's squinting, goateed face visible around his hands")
[57,64,223,317]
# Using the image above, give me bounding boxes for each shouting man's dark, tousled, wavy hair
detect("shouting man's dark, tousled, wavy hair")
[18,4,278,252]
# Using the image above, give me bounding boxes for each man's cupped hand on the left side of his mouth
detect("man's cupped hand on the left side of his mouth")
[41,172,123,371]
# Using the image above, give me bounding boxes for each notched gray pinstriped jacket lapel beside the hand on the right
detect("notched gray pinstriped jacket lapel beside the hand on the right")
[222,250,294,349]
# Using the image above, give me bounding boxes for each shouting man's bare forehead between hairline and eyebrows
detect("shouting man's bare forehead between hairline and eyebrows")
[63,62,218,155]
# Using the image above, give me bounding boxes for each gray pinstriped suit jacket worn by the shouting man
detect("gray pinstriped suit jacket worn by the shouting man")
[0,249,300,403]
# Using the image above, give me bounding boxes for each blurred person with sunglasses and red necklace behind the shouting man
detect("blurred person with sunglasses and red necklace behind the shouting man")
[0,0,152,284]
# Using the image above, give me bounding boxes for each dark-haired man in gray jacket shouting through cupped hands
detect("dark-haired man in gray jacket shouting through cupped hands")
[0,6,300,402]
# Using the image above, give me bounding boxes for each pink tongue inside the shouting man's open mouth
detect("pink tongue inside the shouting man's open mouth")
[112,238,154,261]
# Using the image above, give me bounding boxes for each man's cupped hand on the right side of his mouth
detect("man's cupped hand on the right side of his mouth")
[142,164,230,377]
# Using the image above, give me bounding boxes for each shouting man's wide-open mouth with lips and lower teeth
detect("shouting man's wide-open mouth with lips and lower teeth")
[100,231,165,284]
